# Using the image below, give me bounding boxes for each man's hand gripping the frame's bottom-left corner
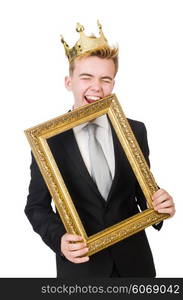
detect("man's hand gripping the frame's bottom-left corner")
[61,233,89,264]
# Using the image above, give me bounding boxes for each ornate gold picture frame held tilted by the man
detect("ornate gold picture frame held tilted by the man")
[25,94,169,255]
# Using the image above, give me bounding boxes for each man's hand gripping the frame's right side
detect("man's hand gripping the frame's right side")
[152,189,175,217]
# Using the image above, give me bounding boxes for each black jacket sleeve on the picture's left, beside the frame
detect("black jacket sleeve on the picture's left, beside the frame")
[25,153,66,254]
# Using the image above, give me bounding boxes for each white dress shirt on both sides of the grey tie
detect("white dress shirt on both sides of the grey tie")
[73,115,115,179]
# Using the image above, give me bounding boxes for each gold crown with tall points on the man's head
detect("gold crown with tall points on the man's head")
[61,21,109,62]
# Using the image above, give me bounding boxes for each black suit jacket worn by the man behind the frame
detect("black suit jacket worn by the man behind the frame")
[25,120,162,278]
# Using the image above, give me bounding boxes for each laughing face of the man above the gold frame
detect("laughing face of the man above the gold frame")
[65,56,115,108]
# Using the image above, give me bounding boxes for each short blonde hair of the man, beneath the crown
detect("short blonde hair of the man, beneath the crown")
[69,46,118,76]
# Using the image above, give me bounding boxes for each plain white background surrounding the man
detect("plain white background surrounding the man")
[0,0,183,277]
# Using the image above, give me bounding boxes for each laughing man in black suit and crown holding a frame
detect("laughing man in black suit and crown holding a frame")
[25,24,175,278]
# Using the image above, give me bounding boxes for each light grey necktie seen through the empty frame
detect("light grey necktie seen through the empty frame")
[88,123,112,200]
